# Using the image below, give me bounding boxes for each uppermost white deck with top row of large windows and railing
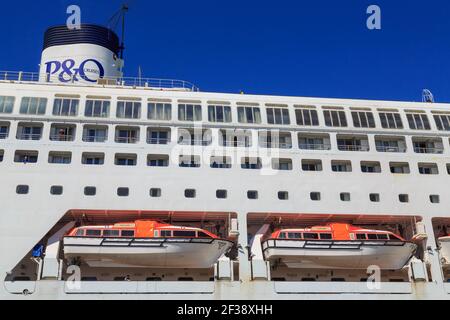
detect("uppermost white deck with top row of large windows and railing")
[0,72,450,136]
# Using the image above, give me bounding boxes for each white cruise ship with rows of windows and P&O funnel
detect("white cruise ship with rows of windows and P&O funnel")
[0,23,450,299]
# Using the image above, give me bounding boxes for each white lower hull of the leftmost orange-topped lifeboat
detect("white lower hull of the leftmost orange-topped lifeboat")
[64,237,233,268]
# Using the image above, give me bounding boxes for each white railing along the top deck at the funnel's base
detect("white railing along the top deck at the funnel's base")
[0,71,200,91]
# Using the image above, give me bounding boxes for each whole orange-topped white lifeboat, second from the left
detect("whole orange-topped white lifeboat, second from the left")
[262,223,417,270]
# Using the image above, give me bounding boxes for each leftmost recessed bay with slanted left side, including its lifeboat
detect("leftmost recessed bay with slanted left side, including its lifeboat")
[5,210,238,284]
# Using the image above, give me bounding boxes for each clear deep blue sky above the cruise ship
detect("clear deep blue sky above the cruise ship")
[0,0,450,102]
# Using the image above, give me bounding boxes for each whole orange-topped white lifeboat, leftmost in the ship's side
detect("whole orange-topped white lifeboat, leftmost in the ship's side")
[64,220,233,268]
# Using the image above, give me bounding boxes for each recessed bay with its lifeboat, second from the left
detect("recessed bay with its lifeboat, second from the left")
[247,213,424,282]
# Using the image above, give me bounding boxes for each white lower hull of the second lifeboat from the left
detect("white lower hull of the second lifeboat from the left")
[263,240,417,270]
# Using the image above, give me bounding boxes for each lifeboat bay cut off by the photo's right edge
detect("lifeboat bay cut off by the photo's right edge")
[432,218,450,282]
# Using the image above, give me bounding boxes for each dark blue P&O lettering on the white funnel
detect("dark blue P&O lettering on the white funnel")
[45,59,105,83]
